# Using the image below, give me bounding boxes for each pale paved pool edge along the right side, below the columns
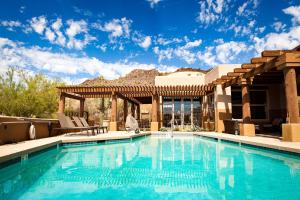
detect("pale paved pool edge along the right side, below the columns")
[194,132,300,154]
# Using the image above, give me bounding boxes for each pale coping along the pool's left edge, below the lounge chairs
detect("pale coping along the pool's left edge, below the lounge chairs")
[0,132,151,166]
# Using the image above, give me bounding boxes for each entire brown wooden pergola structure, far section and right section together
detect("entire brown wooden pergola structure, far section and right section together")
[58,45,300,141]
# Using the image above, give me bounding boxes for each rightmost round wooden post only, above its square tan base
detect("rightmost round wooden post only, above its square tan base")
[283,68,300,123]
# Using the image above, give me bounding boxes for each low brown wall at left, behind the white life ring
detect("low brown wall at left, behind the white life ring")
[0,116,61,145]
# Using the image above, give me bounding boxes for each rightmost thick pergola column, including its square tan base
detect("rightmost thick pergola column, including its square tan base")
[282,68,300,142]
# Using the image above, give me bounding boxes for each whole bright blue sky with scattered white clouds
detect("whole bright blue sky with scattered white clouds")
[0,0,300,83]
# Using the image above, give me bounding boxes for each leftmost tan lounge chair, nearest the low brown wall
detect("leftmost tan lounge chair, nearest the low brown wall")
[54,113,94,135]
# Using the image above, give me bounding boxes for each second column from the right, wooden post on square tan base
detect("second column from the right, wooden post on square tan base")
[240,78,255,136]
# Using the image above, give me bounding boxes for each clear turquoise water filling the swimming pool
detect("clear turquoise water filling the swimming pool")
[0,136,300,200]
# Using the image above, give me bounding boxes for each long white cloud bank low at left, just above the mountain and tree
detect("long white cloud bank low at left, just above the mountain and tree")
[0,38,177,80]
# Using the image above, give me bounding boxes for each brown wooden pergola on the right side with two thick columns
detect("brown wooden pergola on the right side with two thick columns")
[212,45,300,141]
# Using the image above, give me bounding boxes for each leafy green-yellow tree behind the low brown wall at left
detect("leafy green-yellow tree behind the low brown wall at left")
[0,68,62,118]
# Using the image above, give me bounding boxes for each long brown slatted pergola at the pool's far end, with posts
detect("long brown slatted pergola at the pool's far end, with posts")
[58,84,214,131]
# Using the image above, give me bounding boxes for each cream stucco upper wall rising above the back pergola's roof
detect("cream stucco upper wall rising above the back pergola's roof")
[155,72,205,86]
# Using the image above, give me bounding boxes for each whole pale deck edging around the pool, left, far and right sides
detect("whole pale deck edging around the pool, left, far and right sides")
[0,132,300,163]
